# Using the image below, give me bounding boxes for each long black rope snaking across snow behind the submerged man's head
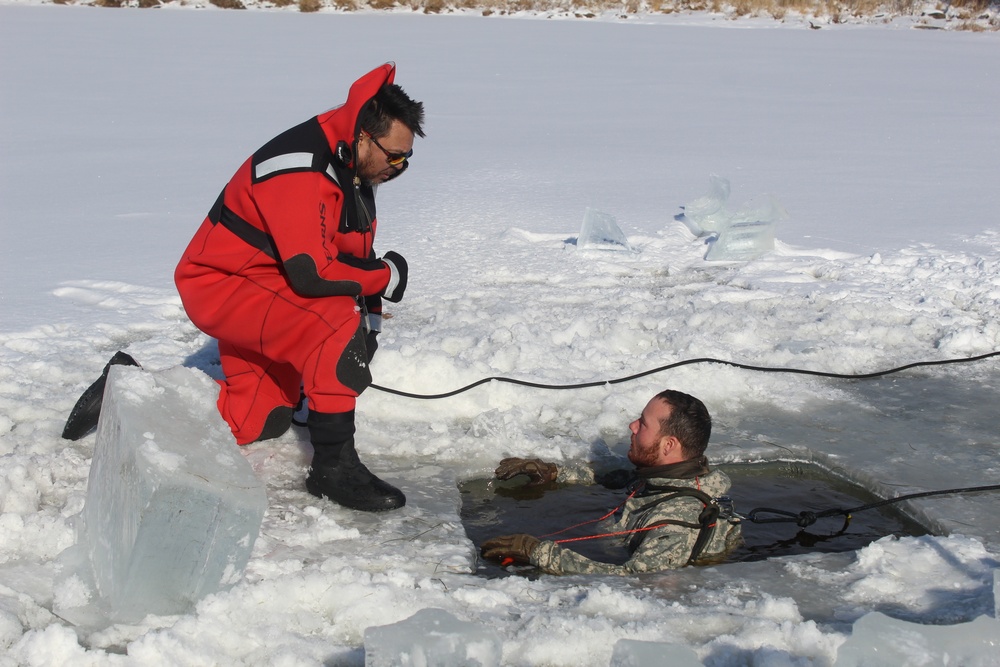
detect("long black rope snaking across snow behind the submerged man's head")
[371,352,1000,399]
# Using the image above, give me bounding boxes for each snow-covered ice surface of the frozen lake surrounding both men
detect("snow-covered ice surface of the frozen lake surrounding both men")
[0,3,1000,667]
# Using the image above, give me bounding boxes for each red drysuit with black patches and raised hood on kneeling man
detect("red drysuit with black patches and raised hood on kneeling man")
[174,64,395,445]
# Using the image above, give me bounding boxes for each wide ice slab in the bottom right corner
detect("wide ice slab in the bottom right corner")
[834,612,1000,667]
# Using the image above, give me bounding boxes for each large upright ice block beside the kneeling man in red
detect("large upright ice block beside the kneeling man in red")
[57,366,267,623]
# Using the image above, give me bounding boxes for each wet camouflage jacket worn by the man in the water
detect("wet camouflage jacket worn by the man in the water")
[531,461,740,575]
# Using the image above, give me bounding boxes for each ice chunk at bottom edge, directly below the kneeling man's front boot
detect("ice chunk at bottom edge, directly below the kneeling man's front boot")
[365,608,502,667]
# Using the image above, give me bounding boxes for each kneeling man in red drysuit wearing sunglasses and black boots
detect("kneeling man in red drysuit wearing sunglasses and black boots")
[174,63,424,511]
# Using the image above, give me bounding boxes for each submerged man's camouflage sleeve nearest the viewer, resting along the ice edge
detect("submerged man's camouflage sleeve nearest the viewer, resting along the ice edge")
[531,526,696,575]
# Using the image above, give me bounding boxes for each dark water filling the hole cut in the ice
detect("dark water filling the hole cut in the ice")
[459,463,928,577]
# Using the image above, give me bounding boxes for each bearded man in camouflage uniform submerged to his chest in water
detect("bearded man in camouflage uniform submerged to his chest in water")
[482,390,740,575]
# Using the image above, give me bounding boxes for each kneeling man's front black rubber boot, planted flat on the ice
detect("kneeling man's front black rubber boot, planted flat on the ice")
[306,410,406,512]
